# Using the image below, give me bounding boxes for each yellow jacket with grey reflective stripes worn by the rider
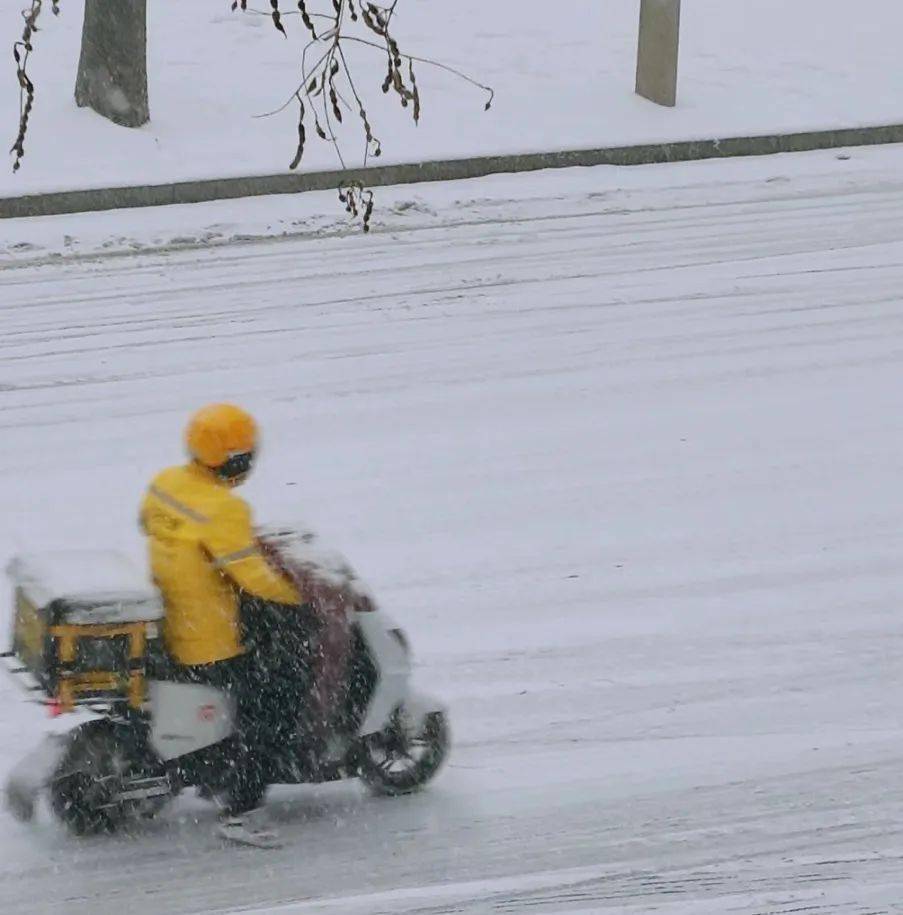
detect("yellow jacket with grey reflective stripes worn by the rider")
[141,464,301,665]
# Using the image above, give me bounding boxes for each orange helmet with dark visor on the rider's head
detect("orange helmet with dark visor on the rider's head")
[185,404,257,483]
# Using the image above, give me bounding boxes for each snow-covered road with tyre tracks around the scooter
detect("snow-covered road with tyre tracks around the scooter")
[0,148,903,915]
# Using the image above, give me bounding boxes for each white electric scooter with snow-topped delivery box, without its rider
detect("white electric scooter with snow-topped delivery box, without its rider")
[3,528,449,834]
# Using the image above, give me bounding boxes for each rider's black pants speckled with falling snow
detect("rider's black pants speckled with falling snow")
[180,608,315,815]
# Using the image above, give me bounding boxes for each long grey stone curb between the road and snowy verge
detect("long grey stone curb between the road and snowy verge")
[0,124,903,219]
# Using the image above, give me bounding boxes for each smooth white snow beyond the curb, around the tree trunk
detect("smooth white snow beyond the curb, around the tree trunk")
[0,0,903,196]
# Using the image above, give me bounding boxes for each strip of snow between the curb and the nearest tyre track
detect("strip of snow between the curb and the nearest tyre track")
[0,145,903,268]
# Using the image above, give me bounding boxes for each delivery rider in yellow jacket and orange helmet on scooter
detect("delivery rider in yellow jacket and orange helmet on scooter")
[141,404,302,844]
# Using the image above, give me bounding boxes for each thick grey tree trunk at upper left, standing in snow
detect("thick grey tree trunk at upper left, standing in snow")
[75,0,150,127]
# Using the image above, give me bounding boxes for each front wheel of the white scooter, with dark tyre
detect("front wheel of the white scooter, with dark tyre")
[360,712,451,797]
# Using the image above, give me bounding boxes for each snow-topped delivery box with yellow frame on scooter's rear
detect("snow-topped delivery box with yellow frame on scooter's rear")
[3,550,163,712]
